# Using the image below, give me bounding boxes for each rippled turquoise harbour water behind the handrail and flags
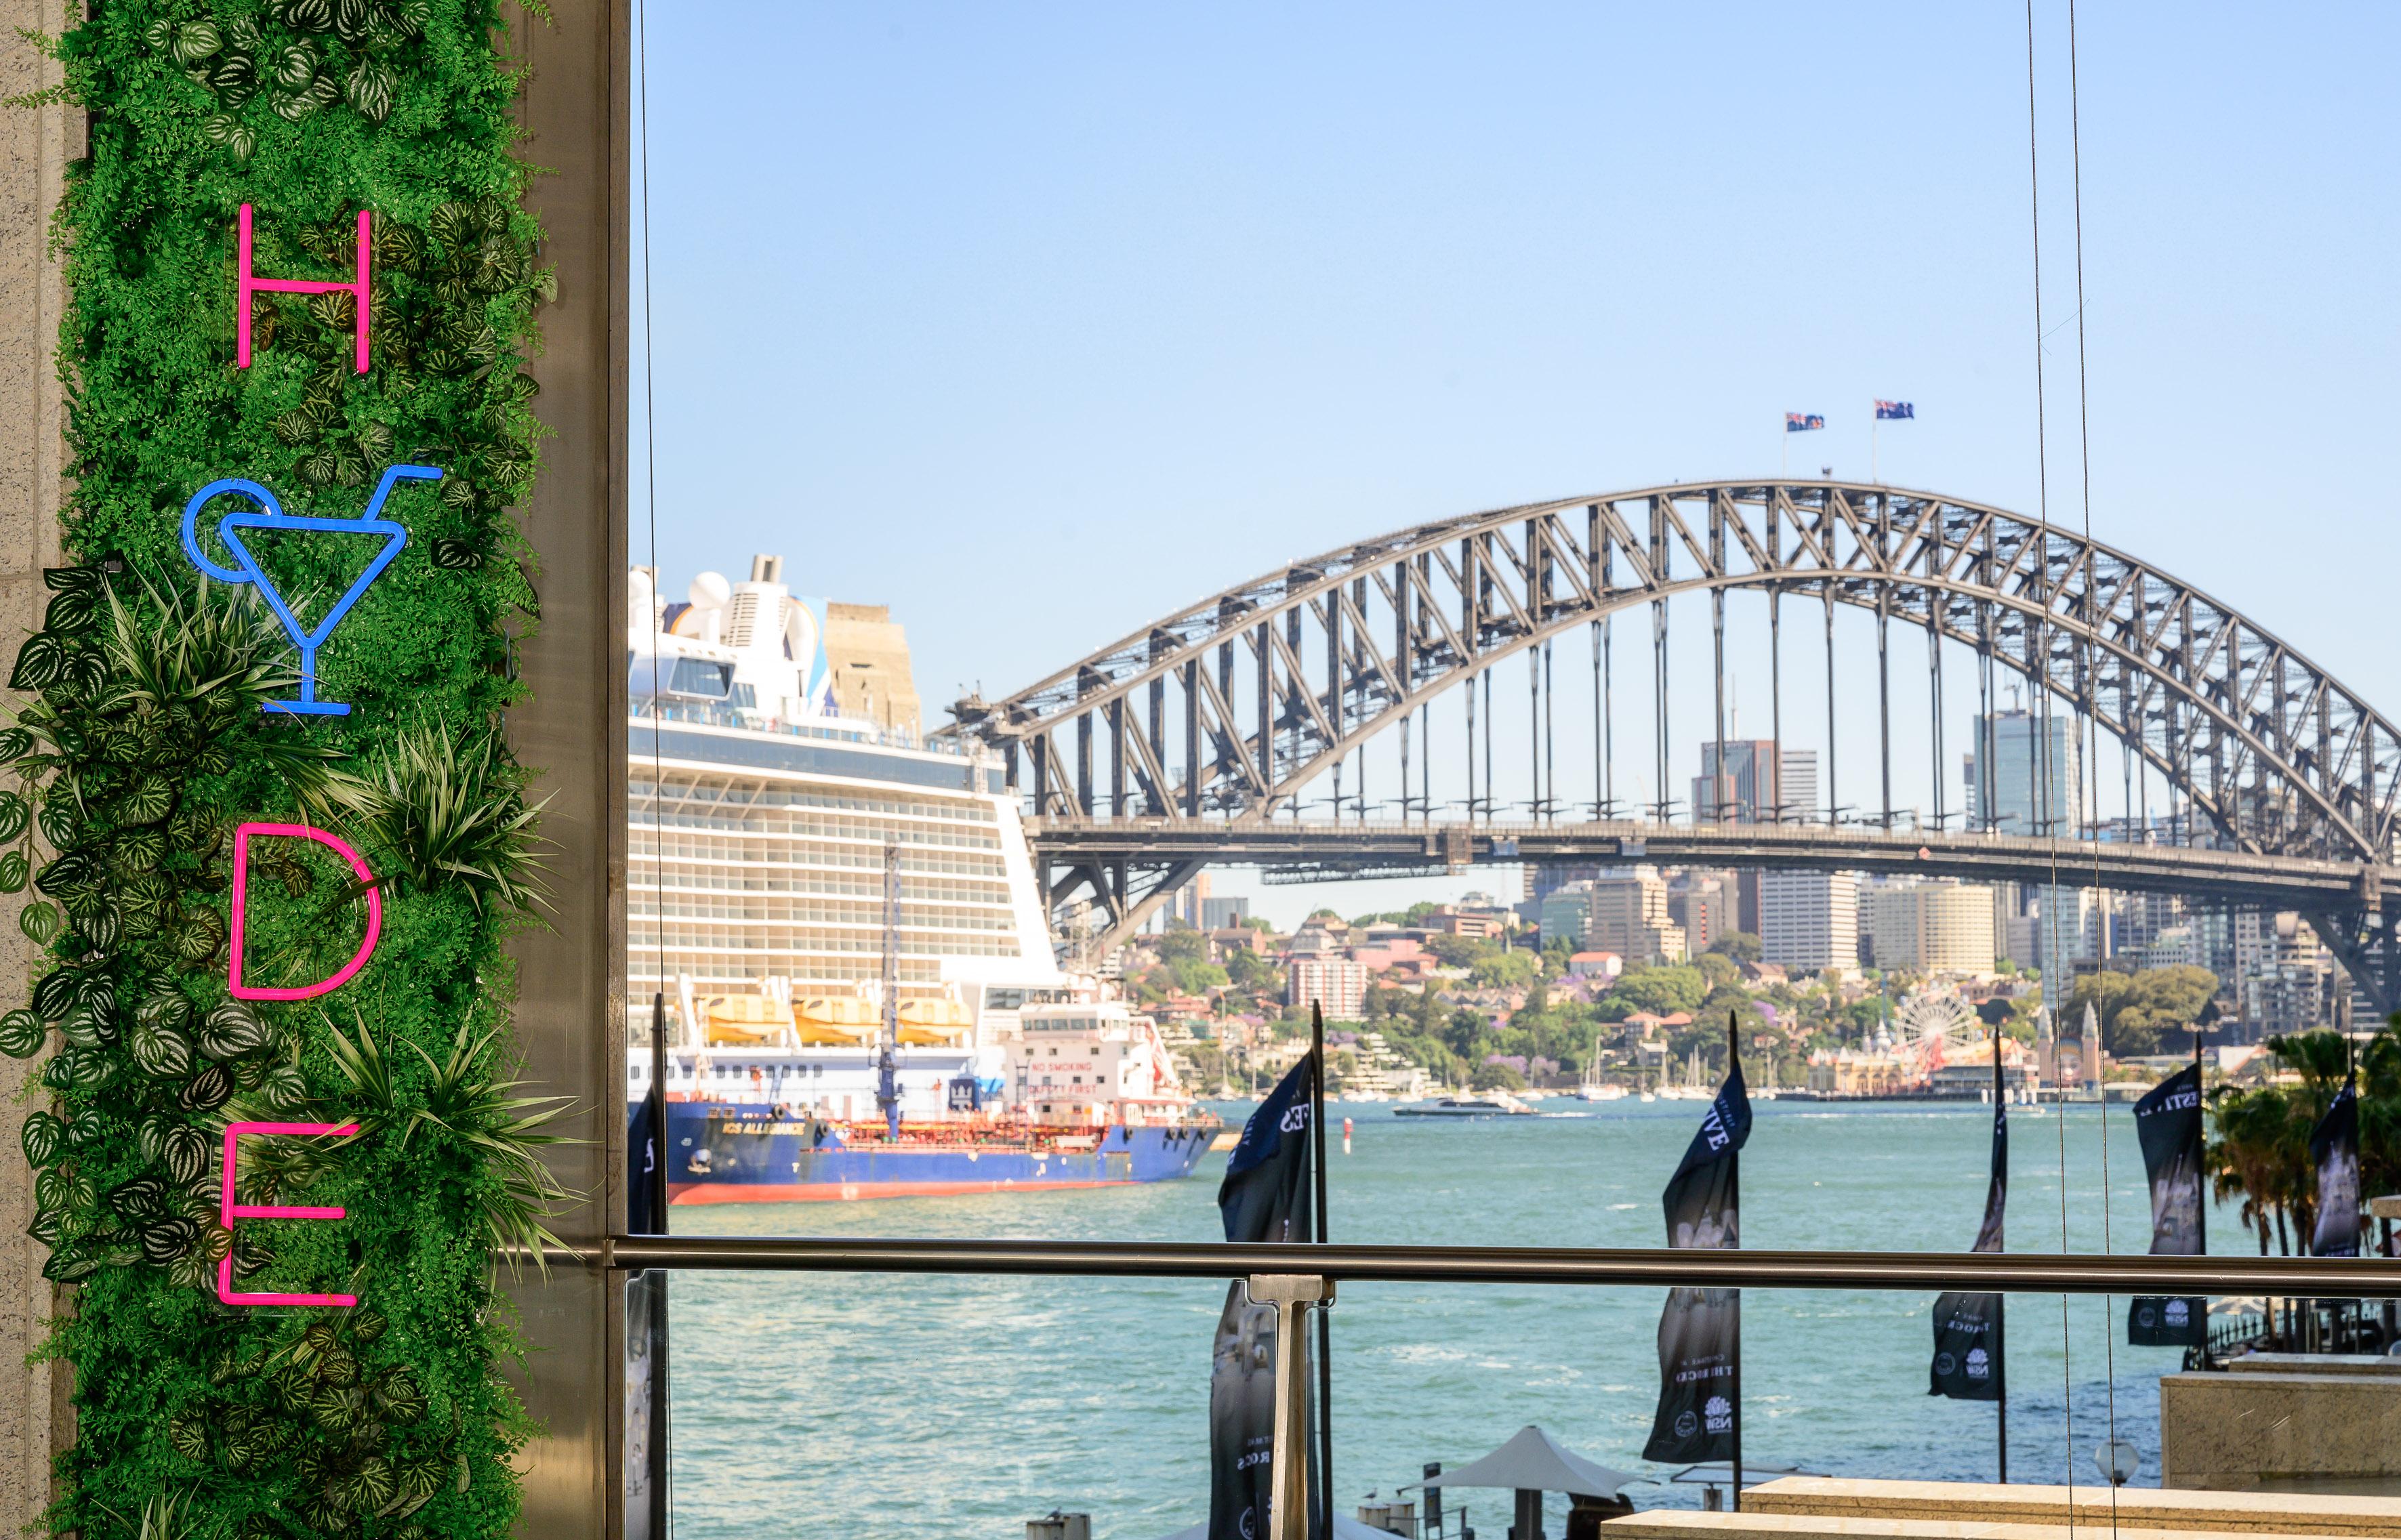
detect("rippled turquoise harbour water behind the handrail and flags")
[672,1101,2228,1540]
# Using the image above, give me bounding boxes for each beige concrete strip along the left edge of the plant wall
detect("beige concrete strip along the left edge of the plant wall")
[0,0,84,1533]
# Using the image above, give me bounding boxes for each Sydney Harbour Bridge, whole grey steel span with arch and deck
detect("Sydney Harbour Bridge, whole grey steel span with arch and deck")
[953,480,2401,1010]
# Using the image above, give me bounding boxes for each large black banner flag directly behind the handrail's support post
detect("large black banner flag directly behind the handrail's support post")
[1208,1058,1316,1540]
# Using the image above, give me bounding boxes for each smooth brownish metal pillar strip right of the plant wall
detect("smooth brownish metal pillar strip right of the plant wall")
[509,0,632,1540]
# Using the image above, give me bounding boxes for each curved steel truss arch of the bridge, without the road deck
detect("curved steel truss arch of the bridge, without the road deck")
[953,480,2401,993]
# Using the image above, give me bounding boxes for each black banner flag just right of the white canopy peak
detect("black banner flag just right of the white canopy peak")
[1642,1058,1750,1465]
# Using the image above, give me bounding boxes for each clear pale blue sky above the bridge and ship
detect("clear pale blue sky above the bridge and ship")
[629,0,2401,909]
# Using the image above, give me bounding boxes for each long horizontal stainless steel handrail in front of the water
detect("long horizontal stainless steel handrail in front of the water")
[595,1235,2401,1300]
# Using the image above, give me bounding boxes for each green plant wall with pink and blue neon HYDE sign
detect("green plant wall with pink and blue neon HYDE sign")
[15,0,554,1540]
